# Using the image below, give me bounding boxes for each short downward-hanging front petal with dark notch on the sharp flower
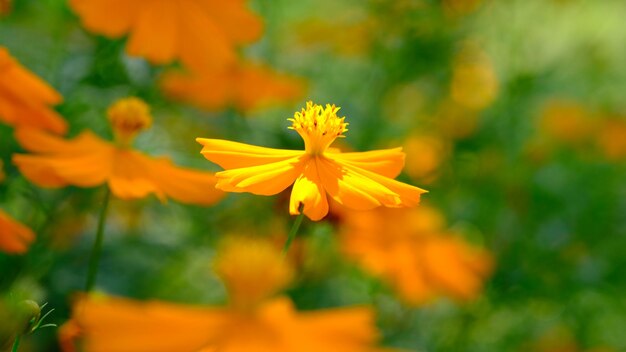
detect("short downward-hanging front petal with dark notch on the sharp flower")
[289,158,328,221]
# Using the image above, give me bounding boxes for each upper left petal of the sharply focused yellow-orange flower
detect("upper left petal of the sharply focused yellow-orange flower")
[196,138,304,170]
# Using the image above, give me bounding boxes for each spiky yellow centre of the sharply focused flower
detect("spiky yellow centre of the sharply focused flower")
[288,101,348,155]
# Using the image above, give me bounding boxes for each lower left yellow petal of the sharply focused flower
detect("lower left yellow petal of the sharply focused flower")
[215,157,303,196]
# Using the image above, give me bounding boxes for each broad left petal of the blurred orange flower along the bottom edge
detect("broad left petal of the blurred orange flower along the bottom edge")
[73,297,227,352]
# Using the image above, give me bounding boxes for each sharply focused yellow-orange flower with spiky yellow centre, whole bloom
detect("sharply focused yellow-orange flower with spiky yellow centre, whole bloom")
[196,102,426,220]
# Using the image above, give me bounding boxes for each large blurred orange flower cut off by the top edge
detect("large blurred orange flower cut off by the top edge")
[70,0,262,71]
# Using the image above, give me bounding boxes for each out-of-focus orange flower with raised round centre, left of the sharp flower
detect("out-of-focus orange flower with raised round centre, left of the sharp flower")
[13,98,222,205]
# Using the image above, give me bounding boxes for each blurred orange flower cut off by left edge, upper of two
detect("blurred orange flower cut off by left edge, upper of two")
[0,46,67,134]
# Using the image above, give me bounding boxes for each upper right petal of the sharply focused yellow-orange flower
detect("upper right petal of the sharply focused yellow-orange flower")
[325,147,405,178]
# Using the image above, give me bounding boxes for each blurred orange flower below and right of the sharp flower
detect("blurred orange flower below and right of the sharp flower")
[340,206,493,305]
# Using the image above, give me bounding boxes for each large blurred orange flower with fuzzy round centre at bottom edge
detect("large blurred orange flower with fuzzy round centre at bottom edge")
[64,239,386,352]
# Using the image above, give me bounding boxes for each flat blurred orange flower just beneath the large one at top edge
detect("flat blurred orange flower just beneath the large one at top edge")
[161,64,303,111]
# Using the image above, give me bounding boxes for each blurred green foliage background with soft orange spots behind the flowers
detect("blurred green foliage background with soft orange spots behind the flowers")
[0,0,626,352]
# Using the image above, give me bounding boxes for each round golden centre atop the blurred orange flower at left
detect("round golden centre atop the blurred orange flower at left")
[107,98,152,147]
